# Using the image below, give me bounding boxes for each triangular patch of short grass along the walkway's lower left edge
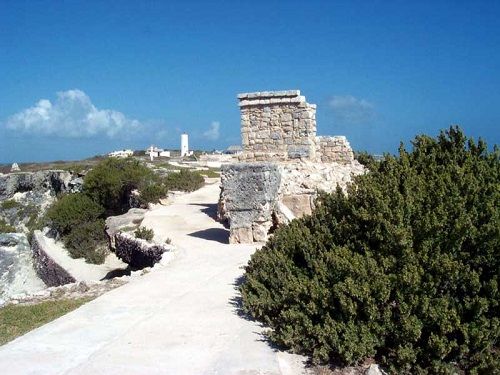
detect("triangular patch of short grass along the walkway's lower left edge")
[0,298,90,345]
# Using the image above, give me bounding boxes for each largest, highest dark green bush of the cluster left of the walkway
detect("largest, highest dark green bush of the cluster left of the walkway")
[83,158,156,215]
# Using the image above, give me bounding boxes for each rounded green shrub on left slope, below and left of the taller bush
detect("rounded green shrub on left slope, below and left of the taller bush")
[46,193,104,236]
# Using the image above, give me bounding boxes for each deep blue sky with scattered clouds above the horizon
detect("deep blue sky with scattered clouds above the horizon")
[0,0,500,163]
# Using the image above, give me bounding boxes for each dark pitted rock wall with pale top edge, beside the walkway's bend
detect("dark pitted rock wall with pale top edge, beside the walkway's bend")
[113,232,173,269]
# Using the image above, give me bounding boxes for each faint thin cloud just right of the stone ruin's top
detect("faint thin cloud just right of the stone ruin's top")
[328,95,375,124]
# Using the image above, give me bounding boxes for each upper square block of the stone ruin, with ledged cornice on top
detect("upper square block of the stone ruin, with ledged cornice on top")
[238,90,316,161]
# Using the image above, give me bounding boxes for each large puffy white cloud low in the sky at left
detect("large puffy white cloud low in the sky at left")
[6,90,141,138]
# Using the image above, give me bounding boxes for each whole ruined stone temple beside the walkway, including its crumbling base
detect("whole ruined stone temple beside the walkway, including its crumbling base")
[218,90,364,243]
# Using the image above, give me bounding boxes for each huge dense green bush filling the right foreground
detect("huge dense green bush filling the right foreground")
[241,128,500,374]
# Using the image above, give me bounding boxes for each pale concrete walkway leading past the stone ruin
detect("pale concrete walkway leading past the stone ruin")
[0,184,305,374]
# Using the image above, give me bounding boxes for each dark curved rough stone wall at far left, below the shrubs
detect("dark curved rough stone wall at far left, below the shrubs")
[31,231,76,286]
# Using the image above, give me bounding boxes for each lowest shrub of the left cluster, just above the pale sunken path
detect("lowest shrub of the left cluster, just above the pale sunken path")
[62,219,107,264]
